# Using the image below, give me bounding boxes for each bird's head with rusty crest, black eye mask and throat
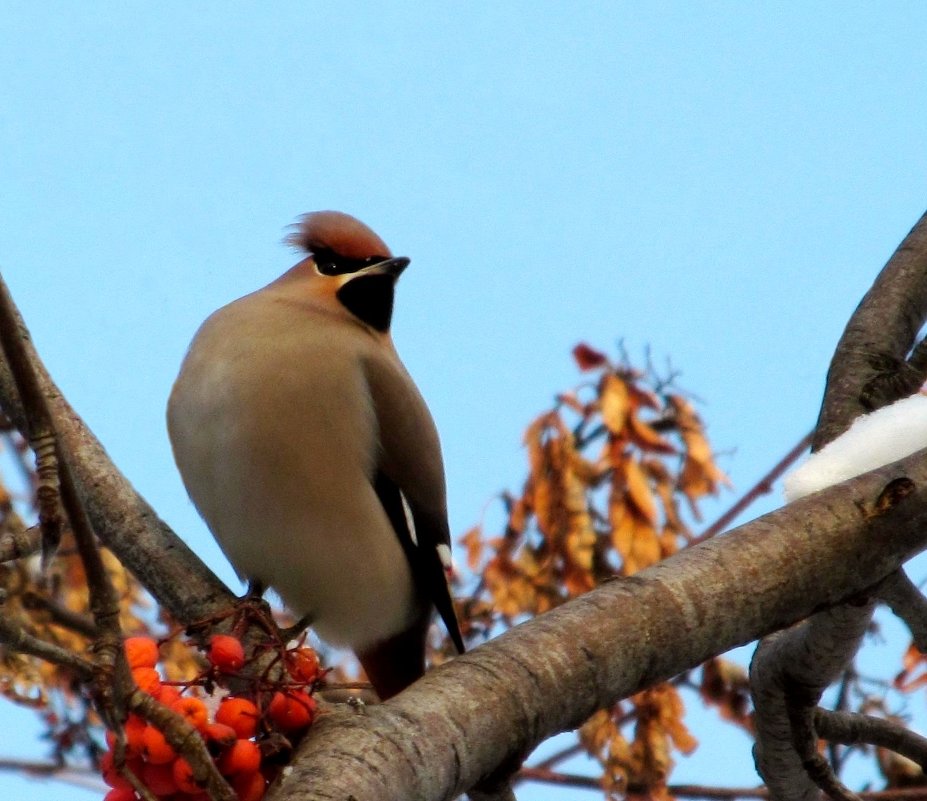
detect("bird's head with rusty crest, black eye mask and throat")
[286,211,409,333]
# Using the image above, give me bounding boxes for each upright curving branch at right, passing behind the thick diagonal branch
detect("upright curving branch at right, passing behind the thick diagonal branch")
[751,209,927,801]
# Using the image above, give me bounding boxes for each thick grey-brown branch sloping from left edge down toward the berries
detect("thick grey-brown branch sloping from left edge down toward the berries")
[0,278,234,623]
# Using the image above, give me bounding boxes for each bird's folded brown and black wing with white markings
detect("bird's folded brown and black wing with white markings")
[365,359,464,653]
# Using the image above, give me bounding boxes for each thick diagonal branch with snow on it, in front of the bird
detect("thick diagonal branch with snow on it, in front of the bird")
[268,452,927,801]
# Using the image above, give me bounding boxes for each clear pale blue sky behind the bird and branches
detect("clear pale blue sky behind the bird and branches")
[0,0,927,801]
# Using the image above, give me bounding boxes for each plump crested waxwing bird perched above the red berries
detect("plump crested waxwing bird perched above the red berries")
[167,211,463,699]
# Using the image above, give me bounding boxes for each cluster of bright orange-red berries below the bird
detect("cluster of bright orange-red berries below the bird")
[100,634,323,801]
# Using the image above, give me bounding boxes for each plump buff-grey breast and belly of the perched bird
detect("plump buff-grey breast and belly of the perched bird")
[168,296,414,647]
